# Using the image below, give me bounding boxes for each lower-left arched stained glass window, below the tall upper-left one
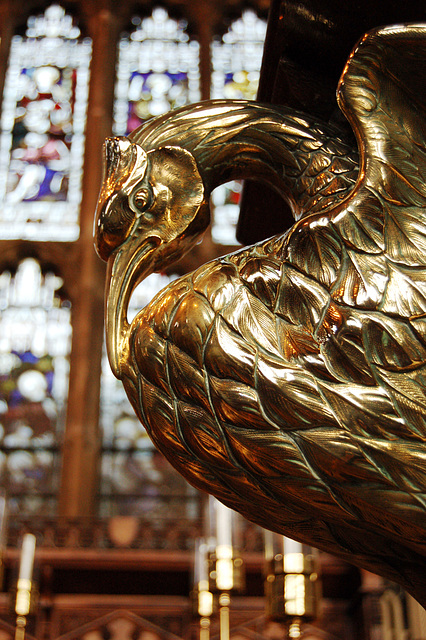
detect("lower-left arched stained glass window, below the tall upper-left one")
[0,258,71,514]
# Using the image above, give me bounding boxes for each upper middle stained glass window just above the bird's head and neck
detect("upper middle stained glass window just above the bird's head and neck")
[114,7,200,135]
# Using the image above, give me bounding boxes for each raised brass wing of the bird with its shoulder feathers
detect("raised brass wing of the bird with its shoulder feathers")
[272,26,426,450]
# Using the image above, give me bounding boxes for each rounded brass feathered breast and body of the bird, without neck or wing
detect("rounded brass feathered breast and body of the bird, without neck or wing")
[123,212,426,596]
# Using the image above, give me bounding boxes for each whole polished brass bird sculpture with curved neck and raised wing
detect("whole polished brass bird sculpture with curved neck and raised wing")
[95,25,426,605]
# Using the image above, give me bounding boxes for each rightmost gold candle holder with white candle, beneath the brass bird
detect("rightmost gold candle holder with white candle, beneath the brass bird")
[265,531,321,638]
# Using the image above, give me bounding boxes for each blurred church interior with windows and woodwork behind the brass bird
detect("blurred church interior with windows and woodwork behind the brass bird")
[0,0,426,640]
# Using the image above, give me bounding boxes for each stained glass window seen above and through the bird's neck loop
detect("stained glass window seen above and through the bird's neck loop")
[211,10,266,245]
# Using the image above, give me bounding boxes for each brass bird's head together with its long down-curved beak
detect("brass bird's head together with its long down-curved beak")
[94,137,209,377]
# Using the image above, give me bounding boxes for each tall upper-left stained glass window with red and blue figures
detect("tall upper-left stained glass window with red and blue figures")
[0,5,91,241]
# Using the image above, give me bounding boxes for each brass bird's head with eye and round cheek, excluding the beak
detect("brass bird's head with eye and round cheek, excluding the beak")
[95,137,209,267]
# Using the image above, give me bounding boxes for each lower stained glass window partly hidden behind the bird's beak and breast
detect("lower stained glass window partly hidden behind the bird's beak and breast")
[100,274,198,517]
